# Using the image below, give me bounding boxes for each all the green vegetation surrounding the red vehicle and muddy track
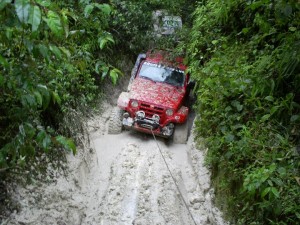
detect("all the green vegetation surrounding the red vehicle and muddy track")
[0,0,300,225]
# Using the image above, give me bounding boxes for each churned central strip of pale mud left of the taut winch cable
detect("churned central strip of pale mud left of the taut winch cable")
[96,143,191,225]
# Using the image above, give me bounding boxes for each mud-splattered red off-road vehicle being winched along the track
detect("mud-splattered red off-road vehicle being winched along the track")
[108,51,192,143]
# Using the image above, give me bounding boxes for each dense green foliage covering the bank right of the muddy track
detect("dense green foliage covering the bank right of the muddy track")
[188,0,300,224]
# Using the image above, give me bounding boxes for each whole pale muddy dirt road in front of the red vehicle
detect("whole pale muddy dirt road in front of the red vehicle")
[3,104,225,225]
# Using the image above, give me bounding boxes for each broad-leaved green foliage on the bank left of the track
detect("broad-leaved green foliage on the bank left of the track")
[0,0,122,171]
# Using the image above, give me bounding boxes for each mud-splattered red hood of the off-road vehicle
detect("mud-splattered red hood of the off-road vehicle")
[130,77,184,109]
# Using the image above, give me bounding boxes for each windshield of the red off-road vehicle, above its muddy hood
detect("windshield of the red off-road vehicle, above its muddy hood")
[139,62,185,87]
